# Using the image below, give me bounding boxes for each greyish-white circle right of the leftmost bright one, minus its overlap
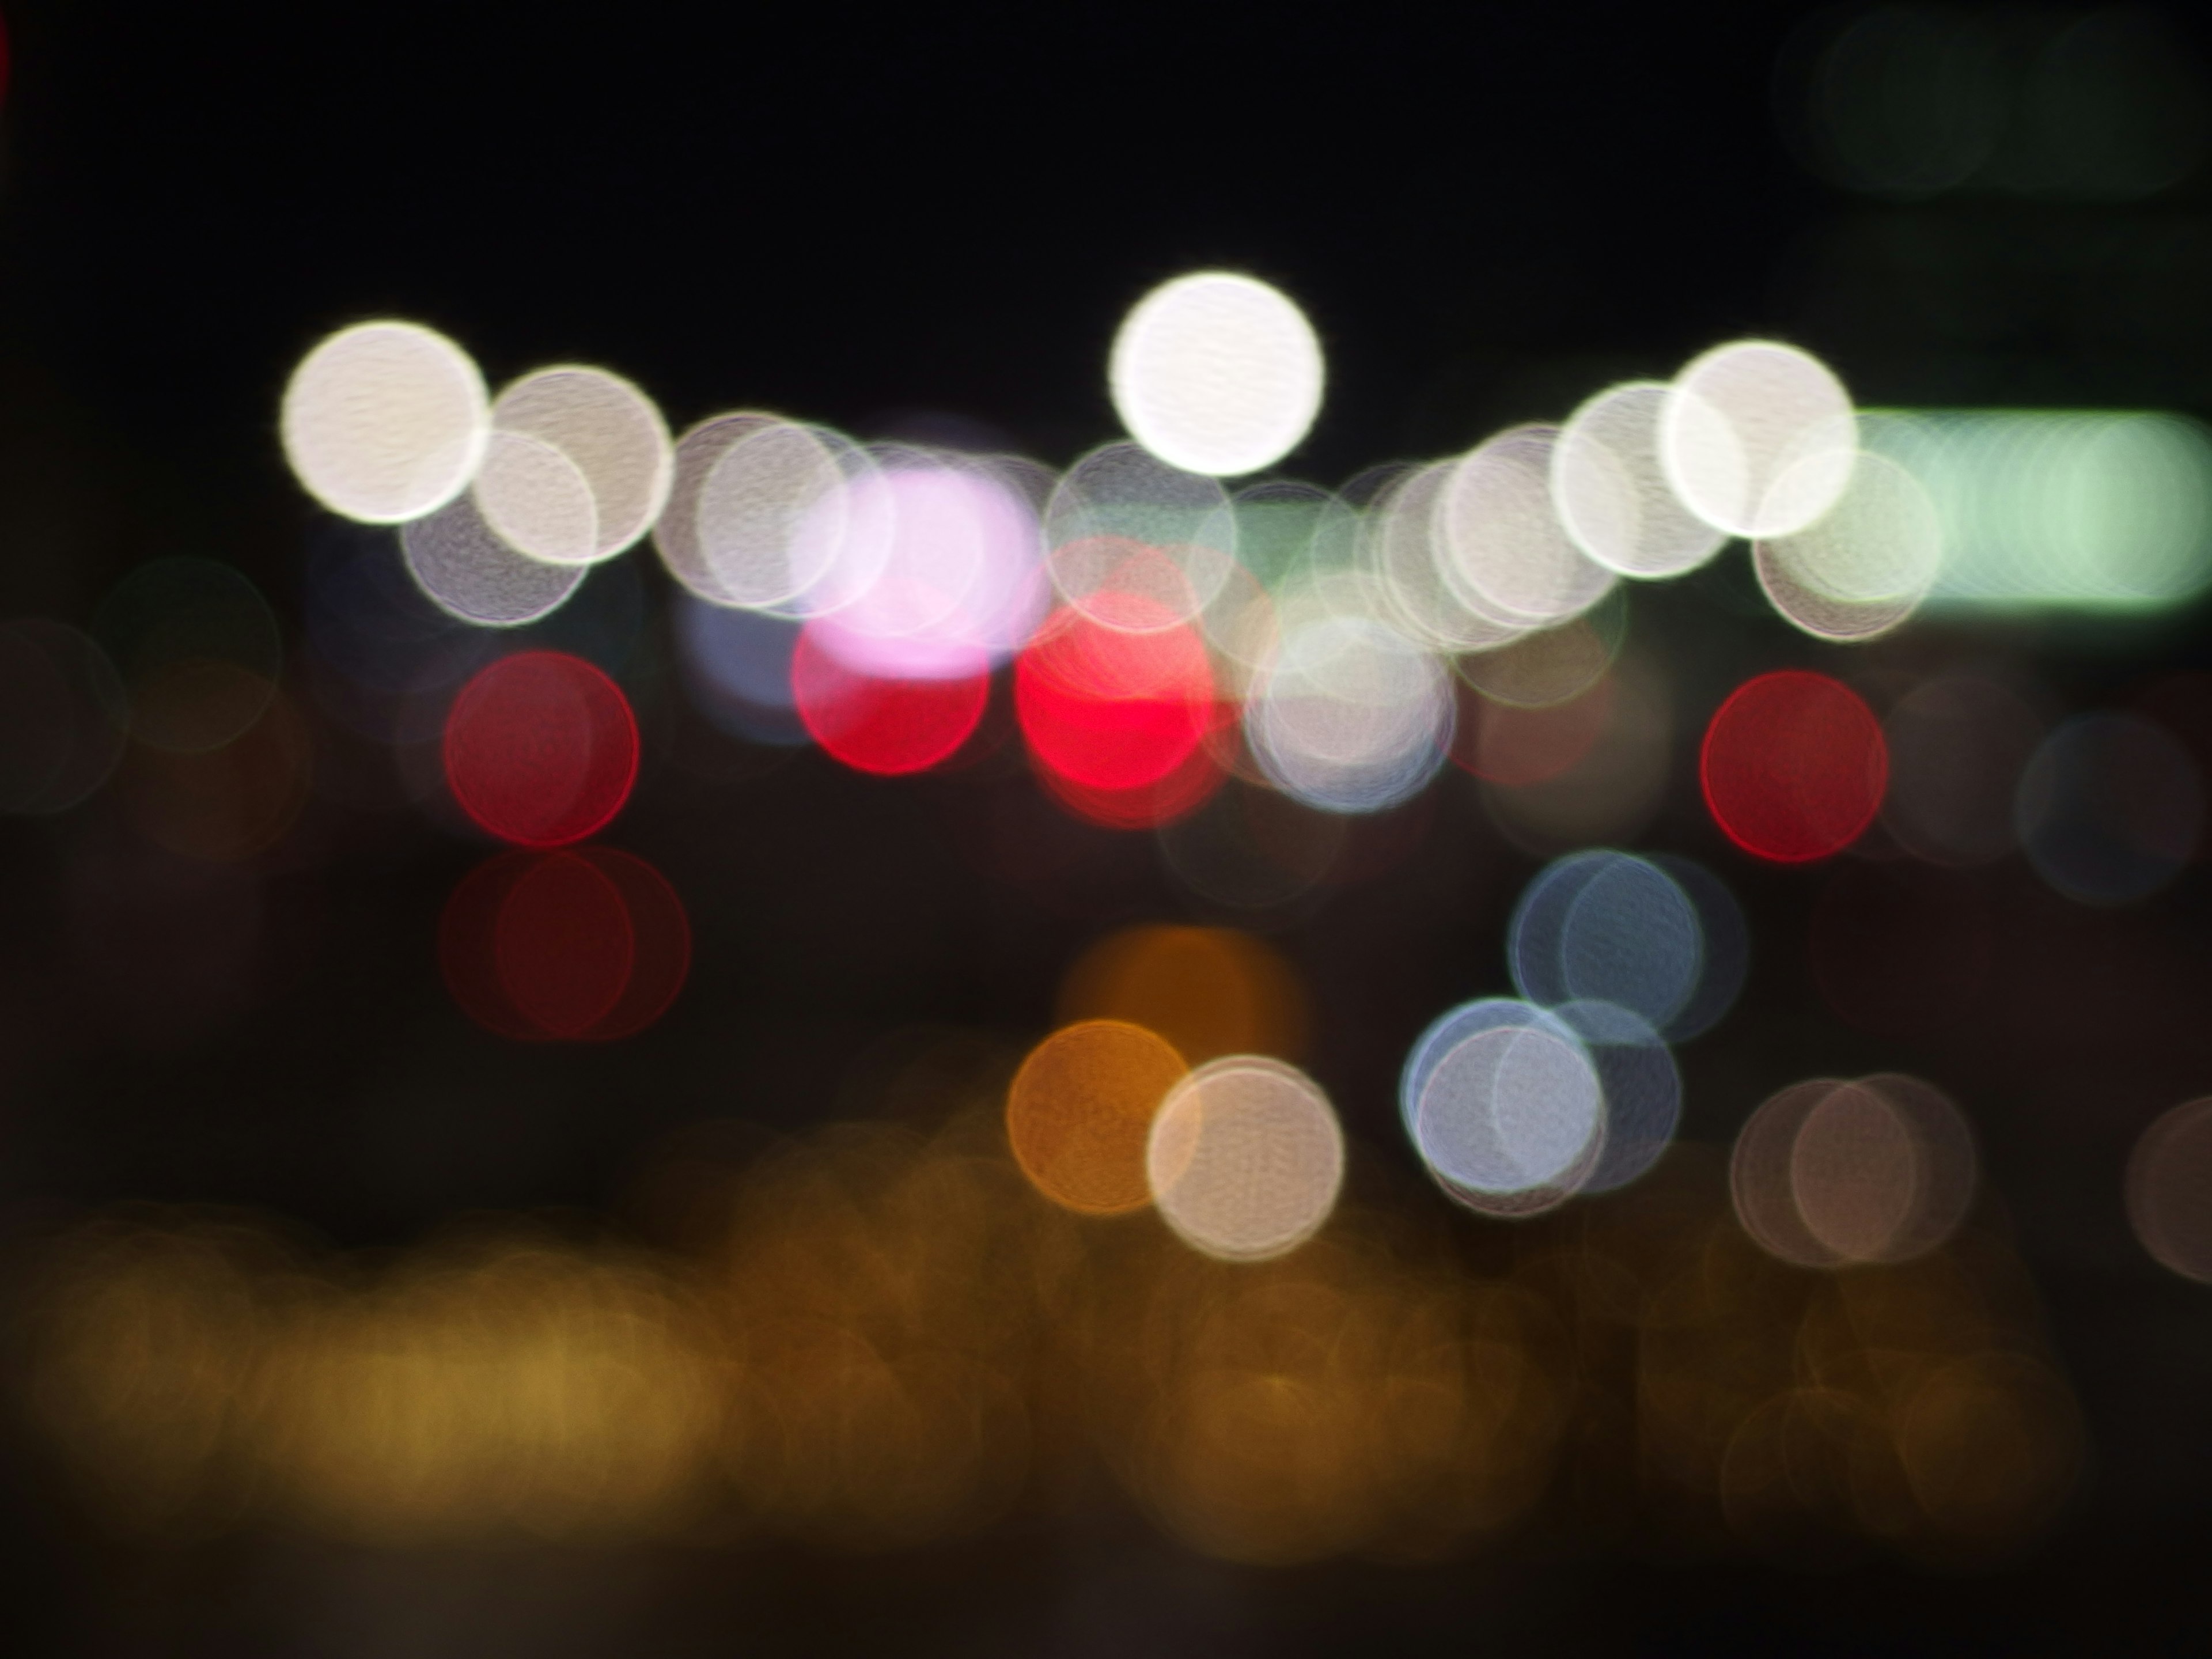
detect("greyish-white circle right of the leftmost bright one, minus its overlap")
[491,365,675,564]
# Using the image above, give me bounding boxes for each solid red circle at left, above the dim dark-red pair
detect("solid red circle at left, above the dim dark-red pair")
[445,650,637,847]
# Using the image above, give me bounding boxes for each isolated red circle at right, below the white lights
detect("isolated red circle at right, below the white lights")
[1696,668,1889,865]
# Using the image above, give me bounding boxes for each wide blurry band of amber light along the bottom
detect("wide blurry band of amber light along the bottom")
[18,1079,2080,1564]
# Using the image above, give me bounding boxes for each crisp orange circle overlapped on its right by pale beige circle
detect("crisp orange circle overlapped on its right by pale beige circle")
[1006,1020,1190,1214]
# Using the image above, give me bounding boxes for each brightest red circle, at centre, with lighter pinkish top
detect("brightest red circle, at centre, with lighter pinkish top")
[1013,593,1217,794]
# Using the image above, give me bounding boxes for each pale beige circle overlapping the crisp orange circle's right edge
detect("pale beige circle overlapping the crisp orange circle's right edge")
[1143,1055,1345,1261]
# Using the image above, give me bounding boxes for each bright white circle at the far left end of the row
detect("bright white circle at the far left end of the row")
[279,323,491,524]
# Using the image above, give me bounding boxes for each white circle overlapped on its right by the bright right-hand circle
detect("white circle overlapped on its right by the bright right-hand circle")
[1551,380,1728,579]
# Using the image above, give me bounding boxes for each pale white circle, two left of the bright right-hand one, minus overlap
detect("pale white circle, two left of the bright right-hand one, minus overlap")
[1435,427,1615,630]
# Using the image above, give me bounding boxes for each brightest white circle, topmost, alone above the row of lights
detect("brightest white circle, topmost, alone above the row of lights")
[1106,270,1325,478]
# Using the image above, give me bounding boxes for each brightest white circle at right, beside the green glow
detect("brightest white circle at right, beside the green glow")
[1659,340,1858,535]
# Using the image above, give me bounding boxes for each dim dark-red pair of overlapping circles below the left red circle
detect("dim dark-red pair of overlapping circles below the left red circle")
[438,847,690,1042]
